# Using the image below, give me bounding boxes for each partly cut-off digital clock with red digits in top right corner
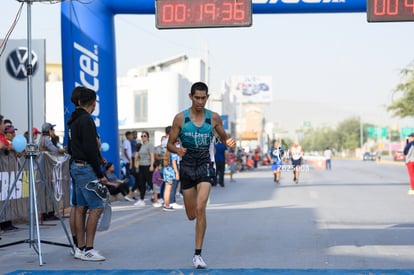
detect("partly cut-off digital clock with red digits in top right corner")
[367,0,414,22]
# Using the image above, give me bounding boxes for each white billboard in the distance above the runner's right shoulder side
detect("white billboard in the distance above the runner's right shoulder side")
[230,76,272,103]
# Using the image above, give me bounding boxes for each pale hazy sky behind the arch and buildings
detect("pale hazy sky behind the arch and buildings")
[0,0,414,130]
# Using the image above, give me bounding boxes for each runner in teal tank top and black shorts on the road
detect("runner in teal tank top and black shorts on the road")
[167,82,235,268]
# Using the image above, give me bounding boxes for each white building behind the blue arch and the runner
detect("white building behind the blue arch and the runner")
[46,54,215,148]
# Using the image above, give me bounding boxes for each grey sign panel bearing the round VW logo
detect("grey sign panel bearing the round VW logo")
[0,39,45,135]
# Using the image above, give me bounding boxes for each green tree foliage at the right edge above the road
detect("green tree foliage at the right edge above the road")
[387,64,414,118]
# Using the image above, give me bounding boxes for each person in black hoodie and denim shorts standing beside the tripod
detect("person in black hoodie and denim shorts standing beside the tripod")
[68,87,108,261]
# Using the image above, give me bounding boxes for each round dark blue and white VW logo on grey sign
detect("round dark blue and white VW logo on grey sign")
[6,47,38,80]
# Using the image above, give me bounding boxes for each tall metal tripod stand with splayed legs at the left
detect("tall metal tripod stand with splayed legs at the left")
[0,0,75,265]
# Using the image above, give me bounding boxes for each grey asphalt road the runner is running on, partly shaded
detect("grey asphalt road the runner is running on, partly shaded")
[0,160,414,274]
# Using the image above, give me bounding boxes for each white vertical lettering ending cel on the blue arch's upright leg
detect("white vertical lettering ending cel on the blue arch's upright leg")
[73,42,101,127]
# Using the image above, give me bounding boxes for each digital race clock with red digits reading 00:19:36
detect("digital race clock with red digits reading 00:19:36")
[155,0,252,29]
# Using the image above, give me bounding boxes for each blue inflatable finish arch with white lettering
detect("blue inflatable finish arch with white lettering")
[61,0,366,171]
